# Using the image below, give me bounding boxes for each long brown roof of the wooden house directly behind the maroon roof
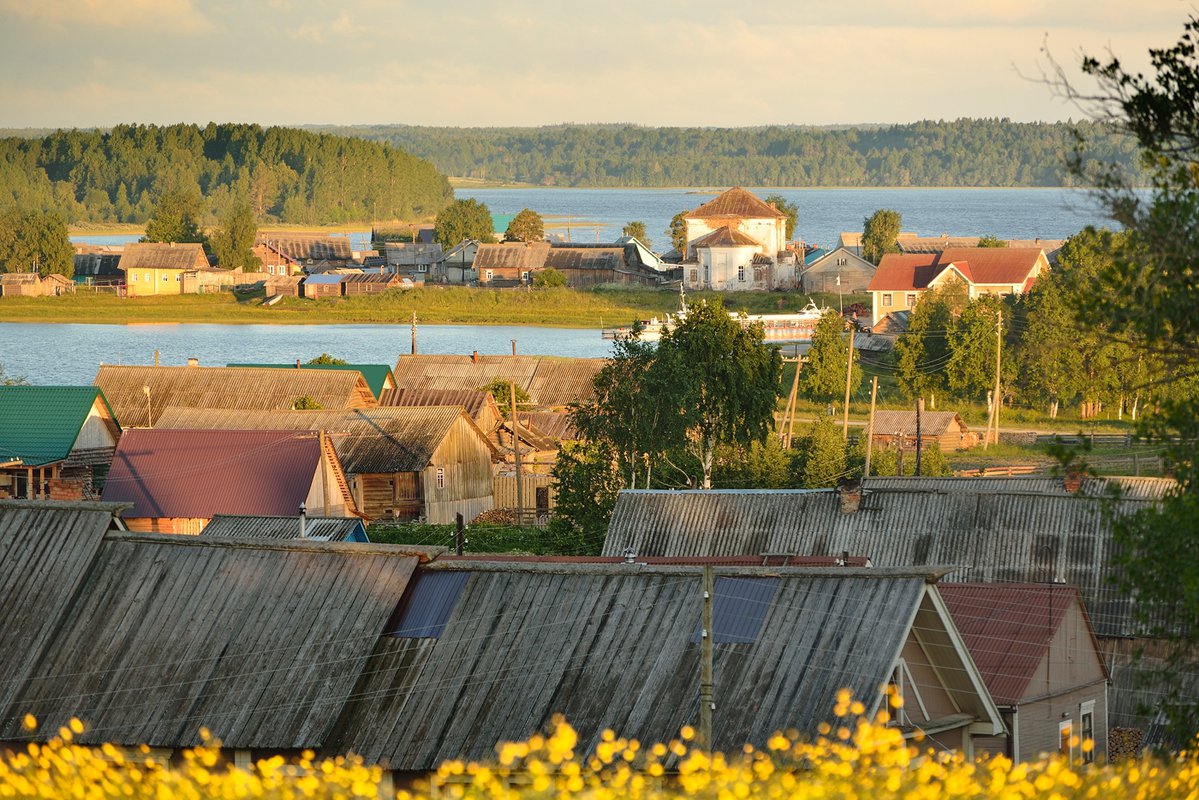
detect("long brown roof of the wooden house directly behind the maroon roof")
[155,405,469,474]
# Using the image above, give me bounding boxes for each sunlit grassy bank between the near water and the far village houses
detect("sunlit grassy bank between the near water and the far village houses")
[0,287,868,327]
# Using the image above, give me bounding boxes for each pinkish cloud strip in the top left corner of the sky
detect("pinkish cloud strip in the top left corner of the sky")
[0,0,213,34]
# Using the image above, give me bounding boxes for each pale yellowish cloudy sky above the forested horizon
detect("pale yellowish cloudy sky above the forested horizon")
[0,0,1194,127]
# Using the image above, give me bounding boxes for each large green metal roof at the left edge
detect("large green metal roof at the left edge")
[0,386,116,467]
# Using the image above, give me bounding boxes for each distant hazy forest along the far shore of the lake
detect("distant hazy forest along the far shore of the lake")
[312,119,1138,187]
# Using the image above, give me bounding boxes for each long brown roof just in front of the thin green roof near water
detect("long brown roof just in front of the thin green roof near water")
[94,366,376,428]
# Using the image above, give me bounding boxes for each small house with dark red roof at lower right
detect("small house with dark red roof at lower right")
[940,583,1108,764]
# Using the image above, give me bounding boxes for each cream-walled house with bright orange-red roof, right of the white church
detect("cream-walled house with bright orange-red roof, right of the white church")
[868,247,1049,319]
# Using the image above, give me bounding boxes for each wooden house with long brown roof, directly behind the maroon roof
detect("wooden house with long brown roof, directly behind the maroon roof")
[157,407,494,524]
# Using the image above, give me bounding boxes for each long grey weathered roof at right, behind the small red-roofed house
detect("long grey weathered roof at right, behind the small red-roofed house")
[603,477,1173,636]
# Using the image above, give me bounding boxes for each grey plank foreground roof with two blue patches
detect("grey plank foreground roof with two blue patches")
[326,561,944,771]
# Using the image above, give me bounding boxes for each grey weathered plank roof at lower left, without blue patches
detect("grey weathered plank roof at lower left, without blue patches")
[0,509,418,750]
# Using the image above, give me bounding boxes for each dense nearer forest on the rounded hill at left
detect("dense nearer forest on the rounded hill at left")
[0,122,453,224]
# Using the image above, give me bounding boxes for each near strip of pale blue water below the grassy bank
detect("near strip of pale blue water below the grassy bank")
[0,323,611,385]
